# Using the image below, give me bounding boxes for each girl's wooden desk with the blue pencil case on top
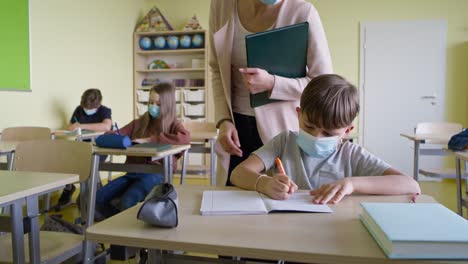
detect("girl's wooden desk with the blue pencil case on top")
[94,145,190,183]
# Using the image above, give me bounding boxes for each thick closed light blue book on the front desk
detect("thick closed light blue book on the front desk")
[360,203,468,259]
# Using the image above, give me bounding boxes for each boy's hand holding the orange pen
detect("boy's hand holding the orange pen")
[260,173,297,200]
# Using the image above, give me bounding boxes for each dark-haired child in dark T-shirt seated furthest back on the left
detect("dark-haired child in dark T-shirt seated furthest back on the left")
[57,88,112,207]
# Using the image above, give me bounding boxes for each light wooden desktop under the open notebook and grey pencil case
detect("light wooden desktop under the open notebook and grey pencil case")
[86,186,455,264]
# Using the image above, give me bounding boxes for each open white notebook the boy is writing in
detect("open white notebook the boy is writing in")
[200,191,333,215]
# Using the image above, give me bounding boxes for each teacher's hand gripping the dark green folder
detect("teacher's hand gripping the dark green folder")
[239,68,275,94]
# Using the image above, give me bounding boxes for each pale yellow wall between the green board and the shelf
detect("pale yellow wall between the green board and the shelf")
[0,0,143,128]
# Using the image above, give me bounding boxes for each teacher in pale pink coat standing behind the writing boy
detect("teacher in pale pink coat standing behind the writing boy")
[209,0,333,185]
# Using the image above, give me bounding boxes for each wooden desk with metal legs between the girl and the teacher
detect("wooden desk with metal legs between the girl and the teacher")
[188,131,218,186]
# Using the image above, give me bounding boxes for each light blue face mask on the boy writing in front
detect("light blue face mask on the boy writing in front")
[296,129,339,158]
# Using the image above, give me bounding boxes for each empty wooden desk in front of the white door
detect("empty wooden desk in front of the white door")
[400,133,452,181]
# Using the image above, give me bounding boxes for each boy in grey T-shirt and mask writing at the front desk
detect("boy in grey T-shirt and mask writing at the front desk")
[231,74,421,204]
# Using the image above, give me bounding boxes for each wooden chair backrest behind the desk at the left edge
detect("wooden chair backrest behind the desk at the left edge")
[13,140,93,182]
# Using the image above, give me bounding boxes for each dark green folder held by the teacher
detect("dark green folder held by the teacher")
[245,22,309,107]
